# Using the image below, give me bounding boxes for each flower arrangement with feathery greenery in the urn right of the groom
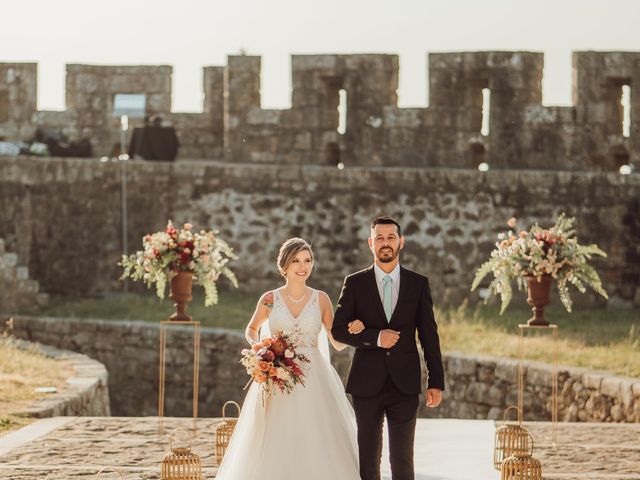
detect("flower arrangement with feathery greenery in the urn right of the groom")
[471,213,608,314]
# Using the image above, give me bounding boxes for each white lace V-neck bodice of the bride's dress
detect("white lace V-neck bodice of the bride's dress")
[269,290,322,347]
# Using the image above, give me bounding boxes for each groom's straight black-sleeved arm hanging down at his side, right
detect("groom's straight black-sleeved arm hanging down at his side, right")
[417,277,444,390]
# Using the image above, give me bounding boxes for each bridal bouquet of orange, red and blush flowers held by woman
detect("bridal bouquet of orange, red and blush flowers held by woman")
[240,333,309,399]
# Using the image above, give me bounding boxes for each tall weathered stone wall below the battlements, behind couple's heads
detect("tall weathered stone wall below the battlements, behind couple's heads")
[0,158,640,304]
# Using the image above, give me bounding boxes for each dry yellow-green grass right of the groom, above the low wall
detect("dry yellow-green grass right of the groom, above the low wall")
[437,304,640,377]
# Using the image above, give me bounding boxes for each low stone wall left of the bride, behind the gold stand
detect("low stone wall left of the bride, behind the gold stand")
[14,317,247,417]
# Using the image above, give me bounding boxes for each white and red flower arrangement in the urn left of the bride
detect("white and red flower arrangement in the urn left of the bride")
[118,220,238,306]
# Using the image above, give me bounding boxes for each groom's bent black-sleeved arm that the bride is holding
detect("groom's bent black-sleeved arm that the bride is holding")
[331,277,380,348]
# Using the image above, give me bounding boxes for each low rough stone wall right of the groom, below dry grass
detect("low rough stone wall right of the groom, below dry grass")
[333,349,640,422]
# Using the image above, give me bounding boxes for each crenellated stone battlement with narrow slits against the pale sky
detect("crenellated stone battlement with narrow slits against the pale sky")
[0,51,640,170]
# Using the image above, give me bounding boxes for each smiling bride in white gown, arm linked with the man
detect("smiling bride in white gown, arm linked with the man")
[216,238,364,480]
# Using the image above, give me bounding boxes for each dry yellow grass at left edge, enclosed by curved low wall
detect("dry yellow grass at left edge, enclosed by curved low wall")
[0,337,72,435]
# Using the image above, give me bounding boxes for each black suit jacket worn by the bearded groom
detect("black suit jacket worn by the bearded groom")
[331,265,444,396]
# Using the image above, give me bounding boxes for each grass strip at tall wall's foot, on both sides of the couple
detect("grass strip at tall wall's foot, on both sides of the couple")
[16,289,640,377]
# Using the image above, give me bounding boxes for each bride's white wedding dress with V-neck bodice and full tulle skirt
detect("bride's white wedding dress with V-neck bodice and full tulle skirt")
[216,290,360,480]
